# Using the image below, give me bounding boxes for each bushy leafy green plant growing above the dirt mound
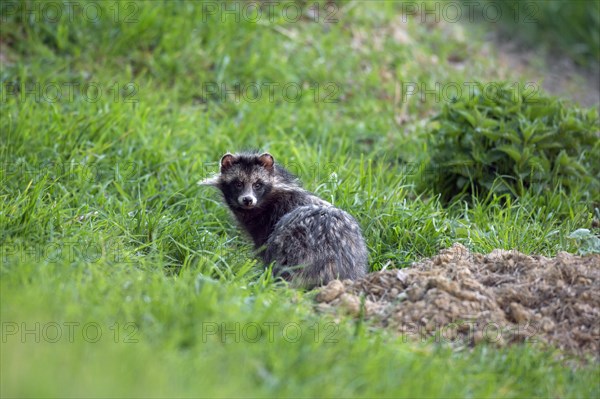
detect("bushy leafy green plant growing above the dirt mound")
[423,83,600,201]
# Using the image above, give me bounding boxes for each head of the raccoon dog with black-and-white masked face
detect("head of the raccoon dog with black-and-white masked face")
[202,152,275,210]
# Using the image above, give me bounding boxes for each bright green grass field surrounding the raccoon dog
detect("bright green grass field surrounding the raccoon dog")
[0,1,600,397]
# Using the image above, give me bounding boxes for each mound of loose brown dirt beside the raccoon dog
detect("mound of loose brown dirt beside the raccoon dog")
[316,244,600,357]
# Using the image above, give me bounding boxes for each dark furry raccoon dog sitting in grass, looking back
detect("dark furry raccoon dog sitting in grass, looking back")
[200,153,367,288]
